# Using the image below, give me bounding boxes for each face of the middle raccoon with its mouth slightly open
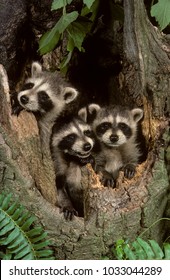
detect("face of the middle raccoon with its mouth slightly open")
[52,120,94,158]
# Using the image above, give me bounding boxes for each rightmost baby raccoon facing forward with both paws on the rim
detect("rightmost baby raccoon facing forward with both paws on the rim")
[79,104,143,187]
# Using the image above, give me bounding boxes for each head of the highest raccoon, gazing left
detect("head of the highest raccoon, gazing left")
[18,62,78,117]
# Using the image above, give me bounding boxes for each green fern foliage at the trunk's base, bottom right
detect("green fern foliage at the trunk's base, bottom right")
[113,237,170,260]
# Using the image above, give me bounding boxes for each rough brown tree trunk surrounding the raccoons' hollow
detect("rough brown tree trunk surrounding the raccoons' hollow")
[0,0,170,259]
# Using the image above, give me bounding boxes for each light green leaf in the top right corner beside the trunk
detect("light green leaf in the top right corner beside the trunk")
[151,0,170,30]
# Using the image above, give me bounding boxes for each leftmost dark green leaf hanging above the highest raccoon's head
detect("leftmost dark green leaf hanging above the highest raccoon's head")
[38,27,61,55]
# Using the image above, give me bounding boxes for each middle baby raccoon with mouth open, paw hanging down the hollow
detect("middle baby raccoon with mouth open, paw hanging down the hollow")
[51,117,94,220]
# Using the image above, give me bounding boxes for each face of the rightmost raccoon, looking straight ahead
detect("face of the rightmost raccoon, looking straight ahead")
[93,107,143,147]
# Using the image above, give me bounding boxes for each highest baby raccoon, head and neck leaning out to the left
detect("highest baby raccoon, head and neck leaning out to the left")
[12,62,79,149]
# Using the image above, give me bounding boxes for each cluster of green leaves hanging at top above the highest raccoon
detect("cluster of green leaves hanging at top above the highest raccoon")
[39,0,123,71]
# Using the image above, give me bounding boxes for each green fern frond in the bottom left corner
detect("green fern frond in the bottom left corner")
[0,194,53,260]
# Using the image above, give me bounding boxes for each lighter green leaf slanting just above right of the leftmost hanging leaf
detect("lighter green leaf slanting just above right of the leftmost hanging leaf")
[54,11,79,34]
